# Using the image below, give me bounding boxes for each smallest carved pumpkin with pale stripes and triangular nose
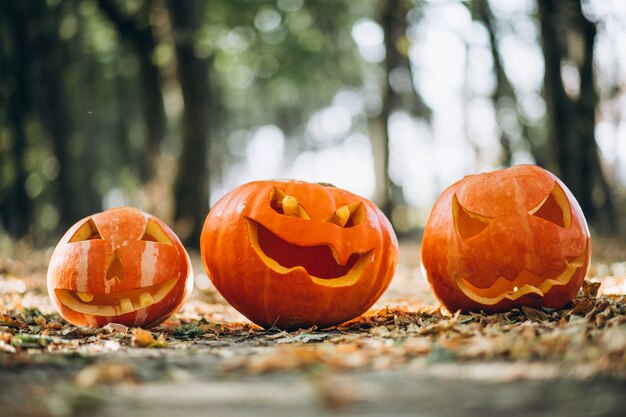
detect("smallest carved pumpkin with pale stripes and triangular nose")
[47,207,193,327]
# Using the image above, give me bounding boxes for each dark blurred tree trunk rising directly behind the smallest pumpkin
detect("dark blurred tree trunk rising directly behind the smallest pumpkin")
[29,2,102,227]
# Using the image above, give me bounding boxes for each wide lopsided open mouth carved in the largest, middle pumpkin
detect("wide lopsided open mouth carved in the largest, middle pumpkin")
[245,218,371,286]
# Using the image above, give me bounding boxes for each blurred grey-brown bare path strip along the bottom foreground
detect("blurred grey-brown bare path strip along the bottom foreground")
[0,350,626,417]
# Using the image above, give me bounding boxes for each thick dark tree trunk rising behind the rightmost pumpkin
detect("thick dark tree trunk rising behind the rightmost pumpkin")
[538,0,617,231]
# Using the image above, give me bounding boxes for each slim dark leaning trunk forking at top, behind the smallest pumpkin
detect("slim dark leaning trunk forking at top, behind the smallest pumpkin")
[98,0,167,182]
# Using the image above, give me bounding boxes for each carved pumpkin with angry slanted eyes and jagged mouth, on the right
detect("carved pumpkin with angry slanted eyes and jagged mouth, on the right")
[422,165,591,312]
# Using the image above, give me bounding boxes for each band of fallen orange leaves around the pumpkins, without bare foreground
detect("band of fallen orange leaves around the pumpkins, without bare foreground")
[0,240,626,380]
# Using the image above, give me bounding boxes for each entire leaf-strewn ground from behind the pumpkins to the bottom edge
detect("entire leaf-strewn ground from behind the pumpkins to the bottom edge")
[0,241,626,416]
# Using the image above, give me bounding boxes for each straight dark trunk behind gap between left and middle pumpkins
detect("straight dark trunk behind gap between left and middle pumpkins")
[167,0,212,246]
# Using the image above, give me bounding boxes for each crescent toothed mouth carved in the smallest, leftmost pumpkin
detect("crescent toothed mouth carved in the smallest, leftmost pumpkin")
[55,278,178,317]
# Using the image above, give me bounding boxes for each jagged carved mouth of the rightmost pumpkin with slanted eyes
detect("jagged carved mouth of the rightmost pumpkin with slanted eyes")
[455,253,587,305]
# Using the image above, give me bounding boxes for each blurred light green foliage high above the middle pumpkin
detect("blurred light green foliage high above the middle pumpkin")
[202,0,361,133]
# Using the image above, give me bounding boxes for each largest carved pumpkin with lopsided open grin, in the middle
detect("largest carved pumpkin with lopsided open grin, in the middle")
[200,180,398,329]
